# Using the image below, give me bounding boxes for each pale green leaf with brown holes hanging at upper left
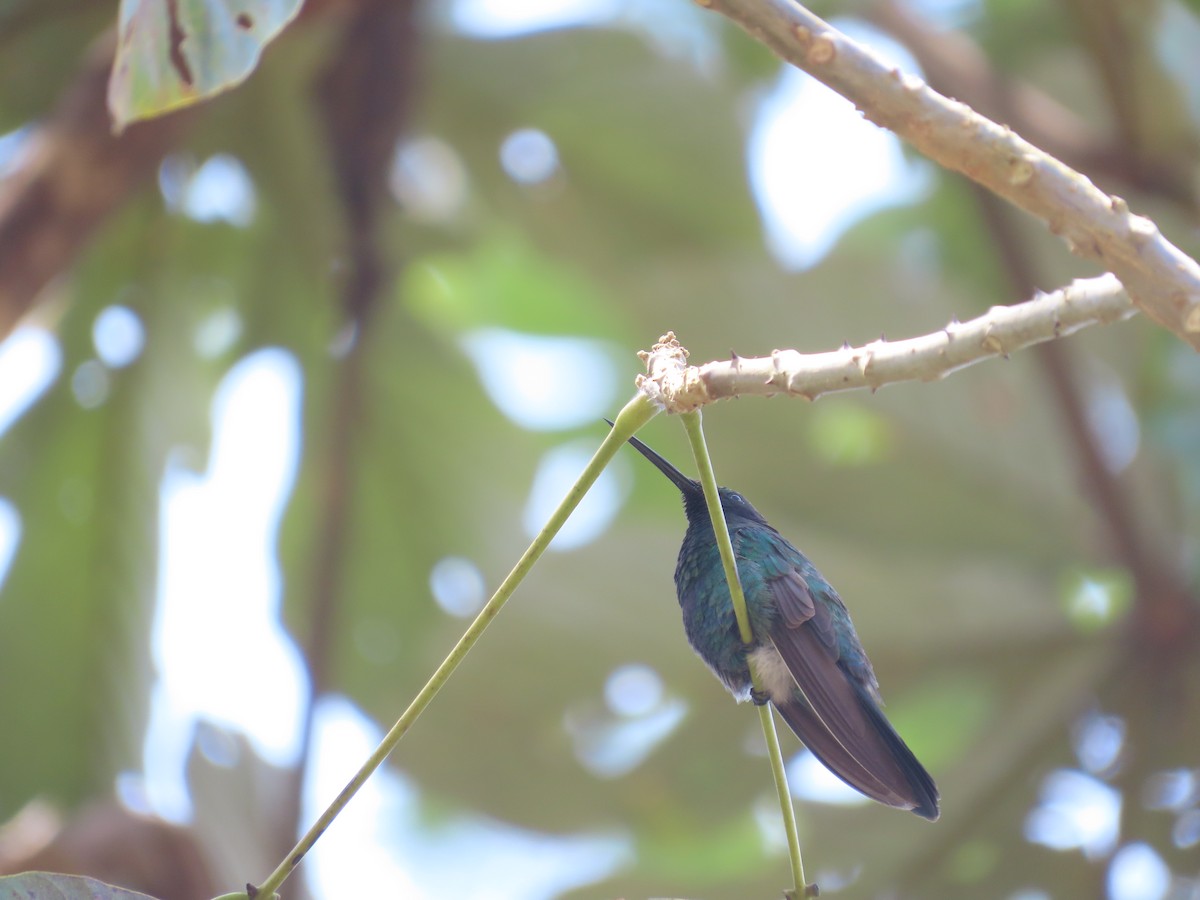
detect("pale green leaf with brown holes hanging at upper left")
[108,0,302,130]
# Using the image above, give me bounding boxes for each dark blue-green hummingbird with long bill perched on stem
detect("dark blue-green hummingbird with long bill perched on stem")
[624,422,938,822]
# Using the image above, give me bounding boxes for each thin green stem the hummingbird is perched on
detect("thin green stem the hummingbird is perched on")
[680,409,809,896]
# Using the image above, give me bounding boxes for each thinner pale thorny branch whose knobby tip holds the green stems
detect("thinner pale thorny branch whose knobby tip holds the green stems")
[637,275,1136,413]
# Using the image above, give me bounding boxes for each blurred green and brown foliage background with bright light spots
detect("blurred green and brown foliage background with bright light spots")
[0,0,1200,900]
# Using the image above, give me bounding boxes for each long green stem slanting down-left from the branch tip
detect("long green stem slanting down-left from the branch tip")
[251,394,659,898]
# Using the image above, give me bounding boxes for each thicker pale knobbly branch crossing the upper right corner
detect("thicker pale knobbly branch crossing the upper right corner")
[700,0,1200,349]
